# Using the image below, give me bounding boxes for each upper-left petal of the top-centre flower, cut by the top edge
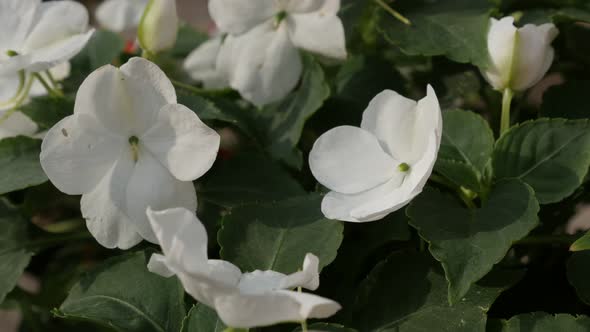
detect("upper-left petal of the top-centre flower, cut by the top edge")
[209,0,279,34]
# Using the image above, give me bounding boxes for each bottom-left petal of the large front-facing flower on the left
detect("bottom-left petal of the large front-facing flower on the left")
[80,151,141,249]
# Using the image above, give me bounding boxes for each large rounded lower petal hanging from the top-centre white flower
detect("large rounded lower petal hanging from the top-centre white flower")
[223,22,303,106]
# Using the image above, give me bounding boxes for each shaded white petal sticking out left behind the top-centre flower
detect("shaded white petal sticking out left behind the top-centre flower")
[183,36,229,89]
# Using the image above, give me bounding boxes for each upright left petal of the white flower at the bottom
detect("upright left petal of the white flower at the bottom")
[146,207,207,269]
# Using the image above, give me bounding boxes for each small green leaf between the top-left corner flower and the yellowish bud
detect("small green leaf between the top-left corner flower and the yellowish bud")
[85,30,125,70]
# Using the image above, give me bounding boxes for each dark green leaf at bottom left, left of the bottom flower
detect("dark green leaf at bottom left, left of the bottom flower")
[54,251,185,332]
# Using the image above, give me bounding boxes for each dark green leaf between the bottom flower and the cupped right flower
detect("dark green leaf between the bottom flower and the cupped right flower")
[218,194,343,273]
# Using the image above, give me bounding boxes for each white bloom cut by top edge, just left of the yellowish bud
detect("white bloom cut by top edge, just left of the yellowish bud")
[95,0,149,32]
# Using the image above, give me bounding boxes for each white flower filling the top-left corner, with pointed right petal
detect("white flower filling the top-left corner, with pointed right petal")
[0,0,94,75]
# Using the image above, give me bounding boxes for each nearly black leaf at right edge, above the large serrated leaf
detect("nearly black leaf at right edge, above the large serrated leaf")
[540,81,590,119]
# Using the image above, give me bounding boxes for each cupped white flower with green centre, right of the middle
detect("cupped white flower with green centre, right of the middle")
[309,86,442,222]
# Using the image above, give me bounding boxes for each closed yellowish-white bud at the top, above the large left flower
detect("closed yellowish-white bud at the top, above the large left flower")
[137,0,178,54]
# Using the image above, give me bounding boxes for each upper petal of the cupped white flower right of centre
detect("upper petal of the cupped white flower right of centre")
[361,90,417,163]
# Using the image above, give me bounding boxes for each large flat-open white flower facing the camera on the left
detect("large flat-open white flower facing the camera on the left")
[41,58,219,249]
